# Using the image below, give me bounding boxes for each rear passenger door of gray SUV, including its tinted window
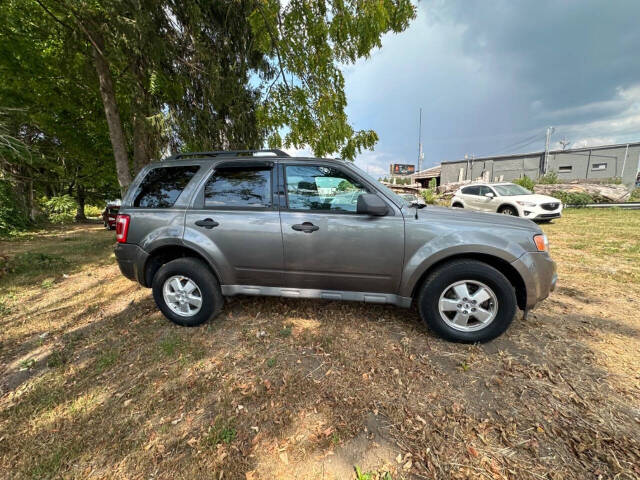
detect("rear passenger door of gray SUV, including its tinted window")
[184,160,283,286]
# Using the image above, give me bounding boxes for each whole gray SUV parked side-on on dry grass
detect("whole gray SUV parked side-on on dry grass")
[115,150,557,342]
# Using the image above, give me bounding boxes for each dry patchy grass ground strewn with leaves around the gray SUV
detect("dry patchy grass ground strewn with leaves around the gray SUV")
[0,209,640,480]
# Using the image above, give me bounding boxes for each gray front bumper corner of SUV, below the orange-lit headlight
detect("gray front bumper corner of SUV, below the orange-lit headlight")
[511,252,558,310]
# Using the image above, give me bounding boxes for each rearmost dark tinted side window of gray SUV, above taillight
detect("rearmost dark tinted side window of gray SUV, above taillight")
[133,165,200,208]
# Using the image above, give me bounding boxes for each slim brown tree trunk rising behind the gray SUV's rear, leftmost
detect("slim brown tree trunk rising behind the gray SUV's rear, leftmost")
[93,39,131,195]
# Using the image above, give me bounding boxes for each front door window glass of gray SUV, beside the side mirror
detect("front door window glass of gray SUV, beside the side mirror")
[285,165,367,212]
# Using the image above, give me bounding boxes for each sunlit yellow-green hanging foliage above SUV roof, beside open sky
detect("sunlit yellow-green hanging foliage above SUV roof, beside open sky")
[249,0,415,160]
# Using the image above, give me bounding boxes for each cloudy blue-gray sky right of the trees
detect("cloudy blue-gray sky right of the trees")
[314,0,640,176]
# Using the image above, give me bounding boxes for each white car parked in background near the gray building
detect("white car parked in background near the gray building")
[451,183,562,222]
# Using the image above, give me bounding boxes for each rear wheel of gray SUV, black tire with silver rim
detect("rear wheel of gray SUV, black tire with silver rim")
[152,257,224,327]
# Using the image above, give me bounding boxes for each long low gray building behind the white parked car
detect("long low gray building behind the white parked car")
[440,142,640,186]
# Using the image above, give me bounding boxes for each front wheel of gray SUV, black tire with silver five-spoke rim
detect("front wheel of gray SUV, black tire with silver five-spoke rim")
[418,260,517,343]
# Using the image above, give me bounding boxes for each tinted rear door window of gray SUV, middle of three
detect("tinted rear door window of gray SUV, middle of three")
[204,167,272,208]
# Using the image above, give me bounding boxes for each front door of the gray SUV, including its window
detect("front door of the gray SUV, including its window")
[279,160,404,293]
